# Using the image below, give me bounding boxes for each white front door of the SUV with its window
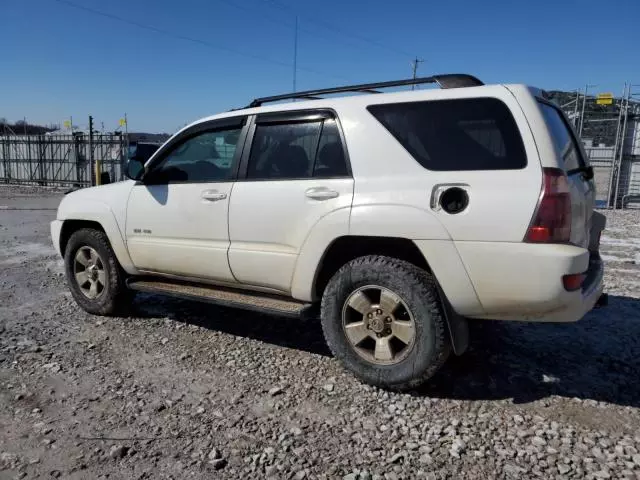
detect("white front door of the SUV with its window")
[126,118,246,283]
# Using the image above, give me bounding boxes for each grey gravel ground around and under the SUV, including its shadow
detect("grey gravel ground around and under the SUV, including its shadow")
[0,187,640,479]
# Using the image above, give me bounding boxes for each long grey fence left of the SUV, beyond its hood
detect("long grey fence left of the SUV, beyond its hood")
[0,132,127,186]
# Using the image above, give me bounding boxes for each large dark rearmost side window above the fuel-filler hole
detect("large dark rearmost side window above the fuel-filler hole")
[368,98,527,171]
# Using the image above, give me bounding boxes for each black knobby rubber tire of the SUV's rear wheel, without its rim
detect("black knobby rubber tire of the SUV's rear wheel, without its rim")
[321,256,451,390]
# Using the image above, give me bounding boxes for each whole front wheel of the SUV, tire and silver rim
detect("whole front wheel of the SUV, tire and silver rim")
[64,228,131,315]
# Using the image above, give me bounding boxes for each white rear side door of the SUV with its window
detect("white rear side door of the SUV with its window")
[229,111,353,293]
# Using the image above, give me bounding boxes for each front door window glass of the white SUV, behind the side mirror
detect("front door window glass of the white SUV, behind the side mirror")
[145,129,240,183]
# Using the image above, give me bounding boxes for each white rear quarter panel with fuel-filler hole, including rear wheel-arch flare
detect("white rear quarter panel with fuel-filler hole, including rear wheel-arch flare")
[322,85,552,315]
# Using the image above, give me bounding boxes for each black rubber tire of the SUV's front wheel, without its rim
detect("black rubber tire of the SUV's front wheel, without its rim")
[64,228,132,315]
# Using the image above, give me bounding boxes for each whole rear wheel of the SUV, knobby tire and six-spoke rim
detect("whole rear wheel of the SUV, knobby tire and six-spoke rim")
[321,256,451,390]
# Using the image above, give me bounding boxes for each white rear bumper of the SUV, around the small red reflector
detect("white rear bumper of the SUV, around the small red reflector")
[456,242,604,322]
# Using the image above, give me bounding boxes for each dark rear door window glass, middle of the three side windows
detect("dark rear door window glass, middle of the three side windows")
[248,119,347,180]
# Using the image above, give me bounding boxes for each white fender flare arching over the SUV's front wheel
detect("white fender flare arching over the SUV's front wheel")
[57,196,137,275]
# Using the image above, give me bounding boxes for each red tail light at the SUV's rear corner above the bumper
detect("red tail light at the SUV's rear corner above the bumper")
[525,168,571,243]
